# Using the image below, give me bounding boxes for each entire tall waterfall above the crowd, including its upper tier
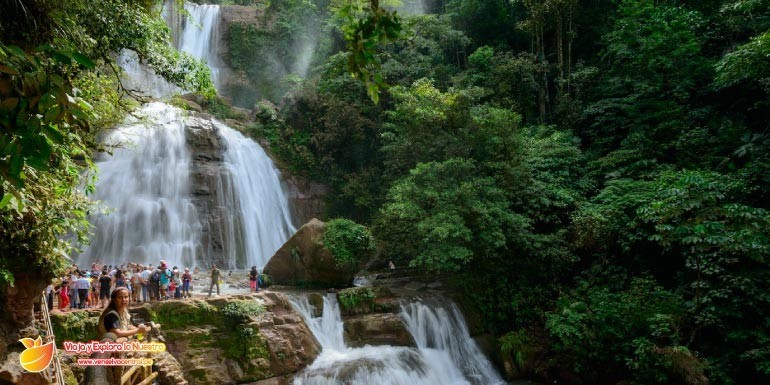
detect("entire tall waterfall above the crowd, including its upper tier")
[78,1,296,269]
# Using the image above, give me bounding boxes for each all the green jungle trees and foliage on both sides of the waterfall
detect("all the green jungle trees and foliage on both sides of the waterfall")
[0,0,770,385]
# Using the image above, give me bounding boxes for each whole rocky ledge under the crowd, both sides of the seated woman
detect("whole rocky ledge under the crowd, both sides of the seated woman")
[52,292,321,385]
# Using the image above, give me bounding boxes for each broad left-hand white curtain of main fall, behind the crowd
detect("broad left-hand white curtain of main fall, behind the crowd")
[78,103,201,266]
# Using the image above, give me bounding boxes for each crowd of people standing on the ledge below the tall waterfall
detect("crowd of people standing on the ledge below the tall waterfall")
[46,260,268,311]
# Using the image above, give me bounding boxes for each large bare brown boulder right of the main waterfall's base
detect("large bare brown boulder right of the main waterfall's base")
[264,218,356,287]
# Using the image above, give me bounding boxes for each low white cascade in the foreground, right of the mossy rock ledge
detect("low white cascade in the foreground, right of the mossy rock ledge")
[292,294,505,385]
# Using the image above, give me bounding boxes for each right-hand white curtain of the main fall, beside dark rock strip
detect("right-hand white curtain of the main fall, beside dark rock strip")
[214,121,296,270]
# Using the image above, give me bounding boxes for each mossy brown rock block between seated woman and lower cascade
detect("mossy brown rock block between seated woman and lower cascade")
[155,293,320,385]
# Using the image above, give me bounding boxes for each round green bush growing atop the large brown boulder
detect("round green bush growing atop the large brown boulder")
[323,218,375,268]
